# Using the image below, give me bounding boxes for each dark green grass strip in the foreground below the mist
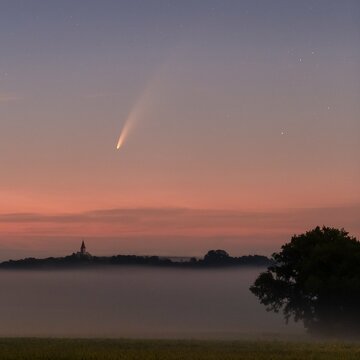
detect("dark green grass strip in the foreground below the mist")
[0,338,360,360]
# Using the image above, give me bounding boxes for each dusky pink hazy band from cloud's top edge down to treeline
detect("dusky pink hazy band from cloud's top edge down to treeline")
[0,204,360,259]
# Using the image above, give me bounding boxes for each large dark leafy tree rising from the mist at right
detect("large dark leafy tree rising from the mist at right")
[250,226,360,335]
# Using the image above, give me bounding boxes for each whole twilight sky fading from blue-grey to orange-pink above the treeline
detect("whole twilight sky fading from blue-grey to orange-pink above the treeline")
[0,0,360,259]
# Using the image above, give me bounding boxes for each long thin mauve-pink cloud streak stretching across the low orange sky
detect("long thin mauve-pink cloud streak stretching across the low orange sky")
[0,205,360,229]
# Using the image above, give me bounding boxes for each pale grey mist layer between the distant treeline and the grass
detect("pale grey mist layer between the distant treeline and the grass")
[0,268,304,338]
